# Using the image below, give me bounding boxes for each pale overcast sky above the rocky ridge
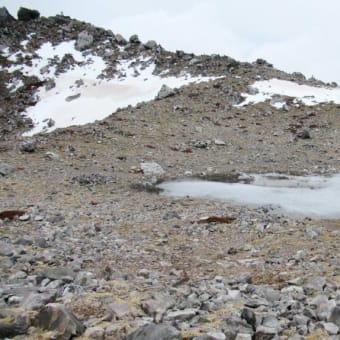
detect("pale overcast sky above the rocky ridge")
[1,0,340,84]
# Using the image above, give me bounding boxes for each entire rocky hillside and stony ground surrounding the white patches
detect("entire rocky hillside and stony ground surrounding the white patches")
[0,5,340,340]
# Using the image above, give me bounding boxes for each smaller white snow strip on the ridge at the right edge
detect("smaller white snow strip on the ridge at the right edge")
[238,79,340,108]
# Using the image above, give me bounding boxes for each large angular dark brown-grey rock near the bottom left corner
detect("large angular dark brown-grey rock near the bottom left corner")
[36,303,85,339]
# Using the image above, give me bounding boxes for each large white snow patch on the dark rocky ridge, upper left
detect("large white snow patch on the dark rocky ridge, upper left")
[1,41,218,136]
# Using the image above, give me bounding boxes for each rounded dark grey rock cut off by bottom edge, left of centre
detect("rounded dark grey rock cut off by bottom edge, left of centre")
[125,323,182,340]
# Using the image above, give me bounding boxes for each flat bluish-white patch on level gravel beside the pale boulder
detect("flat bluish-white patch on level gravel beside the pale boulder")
[159,174,340,218]
